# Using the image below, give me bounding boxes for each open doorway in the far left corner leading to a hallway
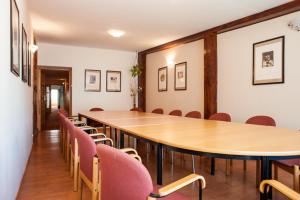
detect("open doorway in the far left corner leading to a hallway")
[39,66,72,130]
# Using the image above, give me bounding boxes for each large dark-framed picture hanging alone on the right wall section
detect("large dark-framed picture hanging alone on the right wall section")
[252,36,284,85]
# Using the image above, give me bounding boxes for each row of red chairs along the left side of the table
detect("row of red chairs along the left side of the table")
[58,109,206,200]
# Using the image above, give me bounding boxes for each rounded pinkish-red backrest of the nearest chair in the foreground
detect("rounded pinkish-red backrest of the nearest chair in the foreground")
[97,144,153,200]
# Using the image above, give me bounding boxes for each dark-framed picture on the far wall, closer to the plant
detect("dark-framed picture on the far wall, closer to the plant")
[106,71,121,92]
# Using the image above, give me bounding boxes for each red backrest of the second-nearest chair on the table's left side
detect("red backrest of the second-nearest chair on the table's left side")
[74,127,97,181]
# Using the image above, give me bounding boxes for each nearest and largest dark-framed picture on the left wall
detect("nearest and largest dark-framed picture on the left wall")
[10,0,20,76]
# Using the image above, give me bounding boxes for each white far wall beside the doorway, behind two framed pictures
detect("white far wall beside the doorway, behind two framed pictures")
[38,43,136,114]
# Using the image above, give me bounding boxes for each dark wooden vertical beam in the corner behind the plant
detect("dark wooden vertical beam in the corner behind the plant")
[138,53,147,111]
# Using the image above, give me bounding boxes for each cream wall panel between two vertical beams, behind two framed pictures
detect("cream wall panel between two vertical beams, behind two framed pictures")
[146,40,204,116]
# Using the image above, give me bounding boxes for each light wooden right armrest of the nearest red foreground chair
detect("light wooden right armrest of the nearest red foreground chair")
[150,174,206,198]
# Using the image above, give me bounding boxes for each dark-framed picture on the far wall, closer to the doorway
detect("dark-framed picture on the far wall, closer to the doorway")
[84,69,101,92]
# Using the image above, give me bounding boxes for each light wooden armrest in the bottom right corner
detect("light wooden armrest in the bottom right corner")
[259,180,300,200]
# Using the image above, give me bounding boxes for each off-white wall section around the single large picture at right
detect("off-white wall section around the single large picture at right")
[218,12,300,129]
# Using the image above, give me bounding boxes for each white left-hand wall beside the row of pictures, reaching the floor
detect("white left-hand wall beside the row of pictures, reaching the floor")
[0,0,32,200]
